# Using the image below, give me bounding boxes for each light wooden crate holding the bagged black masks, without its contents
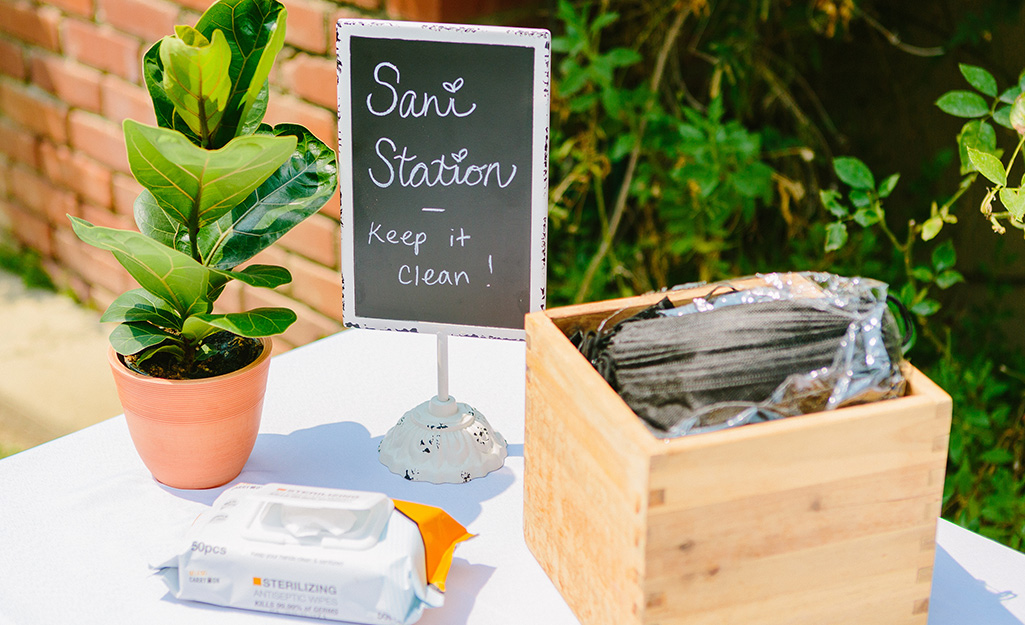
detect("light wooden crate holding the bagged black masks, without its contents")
[524,276,951,625]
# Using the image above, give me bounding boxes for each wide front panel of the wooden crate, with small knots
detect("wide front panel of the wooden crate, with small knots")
[645,364,950,625]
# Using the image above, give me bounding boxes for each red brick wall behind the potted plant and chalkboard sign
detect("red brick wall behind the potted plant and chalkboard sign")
[0,0,524,351]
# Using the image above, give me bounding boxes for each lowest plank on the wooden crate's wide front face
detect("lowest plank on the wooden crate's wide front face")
[645,522,935,625]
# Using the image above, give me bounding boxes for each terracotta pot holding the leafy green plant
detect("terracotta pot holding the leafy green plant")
[108,338,271,489]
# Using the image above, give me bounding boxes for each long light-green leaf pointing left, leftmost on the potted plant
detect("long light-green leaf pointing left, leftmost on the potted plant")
[71,217,210,318]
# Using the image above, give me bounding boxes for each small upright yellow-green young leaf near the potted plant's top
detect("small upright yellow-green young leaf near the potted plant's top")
[160,26,232,142]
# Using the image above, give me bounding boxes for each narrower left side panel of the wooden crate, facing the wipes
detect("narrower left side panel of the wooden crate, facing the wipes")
[524,314,650,625]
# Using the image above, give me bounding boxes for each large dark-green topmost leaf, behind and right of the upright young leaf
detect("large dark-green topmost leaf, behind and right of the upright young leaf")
[196,0,288,147]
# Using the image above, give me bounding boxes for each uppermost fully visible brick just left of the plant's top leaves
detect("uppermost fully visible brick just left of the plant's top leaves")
[64,18,142,82]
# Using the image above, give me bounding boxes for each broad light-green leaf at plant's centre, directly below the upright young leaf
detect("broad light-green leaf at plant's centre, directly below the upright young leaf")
[124,119,296,233]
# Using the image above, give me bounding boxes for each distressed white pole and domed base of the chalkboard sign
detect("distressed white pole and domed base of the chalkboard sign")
[378,332,506,484]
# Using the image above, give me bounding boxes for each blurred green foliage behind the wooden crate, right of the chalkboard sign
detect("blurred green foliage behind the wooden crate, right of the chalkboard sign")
[548,0,1025,549]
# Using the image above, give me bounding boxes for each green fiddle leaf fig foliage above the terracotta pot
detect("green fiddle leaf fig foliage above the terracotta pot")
[71,0,337,378]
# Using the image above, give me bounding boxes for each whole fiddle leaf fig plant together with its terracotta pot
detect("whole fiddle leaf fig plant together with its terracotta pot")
[71,0,337,489]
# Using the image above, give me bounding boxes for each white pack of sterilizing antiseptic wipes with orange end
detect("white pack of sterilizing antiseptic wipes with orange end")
[157,484,470,624]
